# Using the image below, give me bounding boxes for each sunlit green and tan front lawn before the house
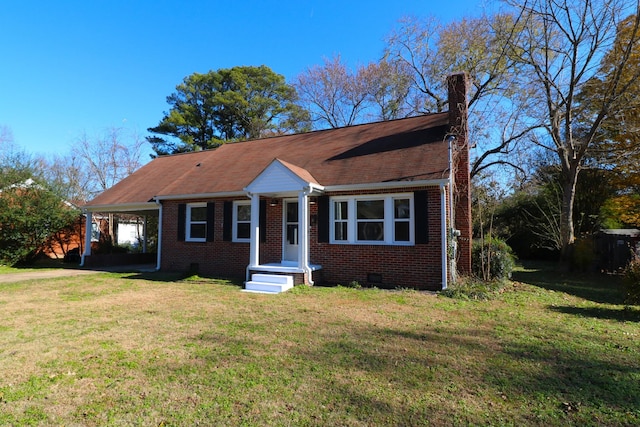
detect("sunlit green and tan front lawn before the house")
[0,266,640,426]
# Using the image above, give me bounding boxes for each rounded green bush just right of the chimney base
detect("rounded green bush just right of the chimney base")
[471,238,515,281]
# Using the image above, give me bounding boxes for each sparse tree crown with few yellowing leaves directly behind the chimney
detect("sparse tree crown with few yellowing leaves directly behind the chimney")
[385,14,538,181]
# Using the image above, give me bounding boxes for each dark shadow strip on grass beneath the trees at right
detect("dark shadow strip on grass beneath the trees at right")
[512,262,624,305]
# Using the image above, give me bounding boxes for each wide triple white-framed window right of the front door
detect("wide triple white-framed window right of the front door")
[329,193,415,245]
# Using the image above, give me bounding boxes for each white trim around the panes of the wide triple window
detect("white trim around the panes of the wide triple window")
[329,193,416,246]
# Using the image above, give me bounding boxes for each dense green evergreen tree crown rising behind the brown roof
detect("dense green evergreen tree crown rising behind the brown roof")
[147,65,309,155]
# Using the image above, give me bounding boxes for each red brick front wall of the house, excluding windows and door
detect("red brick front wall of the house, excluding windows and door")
[161,187,442,290]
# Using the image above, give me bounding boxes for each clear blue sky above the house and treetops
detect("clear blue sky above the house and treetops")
[0,0,486,155]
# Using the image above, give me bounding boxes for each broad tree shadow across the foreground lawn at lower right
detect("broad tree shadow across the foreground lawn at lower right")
[296,325,640,425]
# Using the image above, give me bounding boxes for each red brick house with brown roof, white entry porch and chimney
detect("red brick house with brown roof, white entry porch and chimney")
[83,74,471,290]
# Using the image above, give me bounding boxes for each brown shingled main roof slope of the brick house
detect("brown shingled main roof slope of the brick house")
[86,113,449,207]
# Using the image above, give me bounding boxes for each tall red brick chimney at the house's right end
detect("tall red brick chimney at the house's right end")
[447,73,473,274]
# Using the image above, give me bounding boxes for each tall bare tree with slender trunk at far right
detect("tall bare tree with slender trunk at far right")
[507,0,640,258]
